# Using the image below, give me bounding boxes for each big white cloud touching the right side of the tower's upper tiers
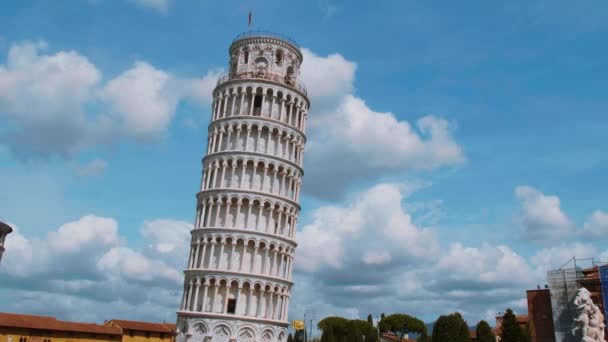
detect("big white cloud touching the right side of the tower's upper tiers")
[302,49,465,199]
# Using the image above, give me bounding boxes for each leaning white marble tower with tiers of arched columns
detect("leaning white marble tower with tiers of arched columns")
[177,32,310,342]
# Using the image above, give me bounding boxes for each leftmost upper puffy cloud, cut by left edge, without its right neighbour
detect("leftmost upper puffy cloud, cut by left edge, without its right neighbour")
[0,42,101,156]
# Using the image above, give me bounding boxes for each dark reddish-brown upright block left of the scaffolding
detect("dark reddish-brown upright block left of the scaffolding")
[526,288,555,342]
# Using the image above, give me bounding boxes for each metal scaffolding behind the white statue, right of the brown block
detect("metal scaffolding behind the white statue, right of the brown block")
[547,258,602,342]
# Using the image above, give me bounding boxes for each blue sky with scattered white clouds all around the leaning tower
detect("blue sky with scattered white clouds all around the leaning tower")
[0,0,608,332]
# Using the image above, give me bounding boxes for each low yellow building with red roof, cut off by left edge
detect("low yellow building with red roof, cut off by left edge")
[0,312,122,342]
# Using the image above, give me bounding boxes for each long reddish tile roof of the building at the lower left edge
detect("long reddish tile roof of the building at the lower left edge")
[0,312,121,335]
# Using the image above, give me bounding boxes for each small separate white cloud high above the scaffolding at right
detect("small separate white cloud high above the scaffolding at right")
[515,185,574,240]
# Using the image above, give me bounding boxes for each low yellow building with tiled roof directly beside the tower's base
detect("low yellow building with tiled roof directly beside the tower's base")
[103,319,176,342]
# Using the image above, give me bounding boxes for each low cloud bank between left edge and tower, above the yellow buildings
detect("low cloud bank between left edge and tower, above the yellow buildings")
[0,215,192,322]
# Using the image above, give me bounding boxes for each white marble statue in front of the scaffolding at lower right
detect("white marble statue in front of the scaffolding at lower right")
[572,287,606,342]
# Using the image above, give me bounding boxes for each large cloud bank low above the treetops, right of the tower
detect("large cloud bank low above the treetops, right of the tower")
[293,184,548,321]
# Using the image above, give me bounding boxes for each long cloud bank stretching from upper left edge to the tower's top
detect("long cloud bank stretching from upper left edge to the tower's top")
[0,42,218,159]
